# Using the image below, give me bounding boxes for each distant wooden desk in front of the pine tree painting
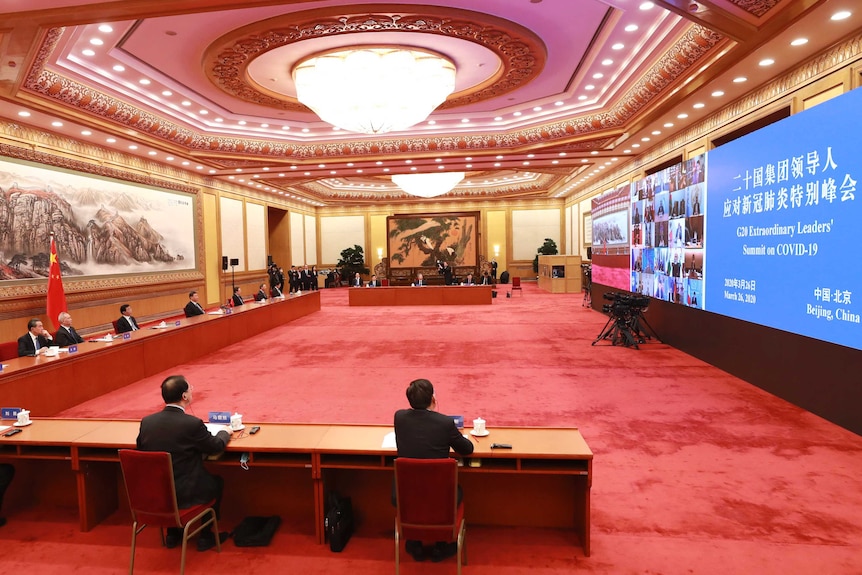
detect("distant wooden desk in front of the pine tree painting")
[348,286,493,306]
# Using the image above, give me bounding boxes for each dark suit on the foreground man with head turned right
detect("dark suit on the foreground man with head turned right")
[137,405,230,507]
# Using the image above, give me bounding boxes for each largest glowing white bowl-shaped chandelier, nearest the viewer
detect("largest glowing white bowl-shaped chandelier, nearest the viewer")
[293,46,455,134]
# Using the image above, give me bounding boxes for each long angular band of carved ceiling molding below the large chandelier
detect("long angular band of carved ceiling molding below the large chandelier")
[23,25,723,162]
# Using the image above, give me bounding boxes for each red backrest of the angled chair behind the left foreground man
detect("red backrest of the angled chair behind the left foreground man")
[120,449,182,527]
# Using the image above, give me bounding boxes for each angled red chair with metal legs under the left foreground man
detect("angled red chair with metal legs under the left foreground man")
[120,449,221,575]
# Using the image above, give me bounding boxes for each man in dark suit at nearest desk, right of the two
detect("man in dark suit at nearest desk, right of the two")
[393,379,473,561]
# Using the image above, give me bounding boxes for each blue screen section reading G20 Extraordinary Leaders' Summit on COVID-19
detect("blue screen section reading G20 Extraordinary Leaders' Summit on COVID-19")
[705,84,862,349]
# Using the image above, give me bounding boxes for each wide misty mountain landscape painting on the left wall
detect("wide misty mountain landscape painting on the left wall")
[0,159,196,280]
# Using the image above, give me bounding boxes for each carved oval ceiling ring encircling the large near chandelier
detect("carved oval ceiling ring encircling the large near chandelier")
[203,5,547,113]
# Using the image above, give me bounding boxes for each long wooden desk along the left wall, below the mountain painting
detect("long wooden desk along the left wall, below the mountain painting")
[0,292,320,417]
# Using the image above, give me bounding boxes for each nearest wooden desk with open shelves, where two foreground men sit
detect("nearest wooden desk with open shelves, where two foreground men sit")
[0,419,593,556]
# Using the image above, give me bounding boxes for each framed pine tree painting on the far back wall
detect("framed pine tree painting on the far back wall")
[387,213,479,268]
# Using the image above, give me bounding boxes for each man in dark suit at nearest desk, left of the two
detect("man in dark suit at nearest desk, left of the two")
[137,375,231,551]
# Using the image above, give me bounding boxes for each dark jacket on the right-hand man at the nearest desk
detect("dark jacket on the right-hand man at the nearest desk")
[395,409,473,459]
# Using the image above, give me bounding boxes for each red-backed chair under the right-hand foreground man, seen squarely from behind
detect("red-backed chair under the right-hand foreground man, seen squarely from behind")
[395,457,467,575]
